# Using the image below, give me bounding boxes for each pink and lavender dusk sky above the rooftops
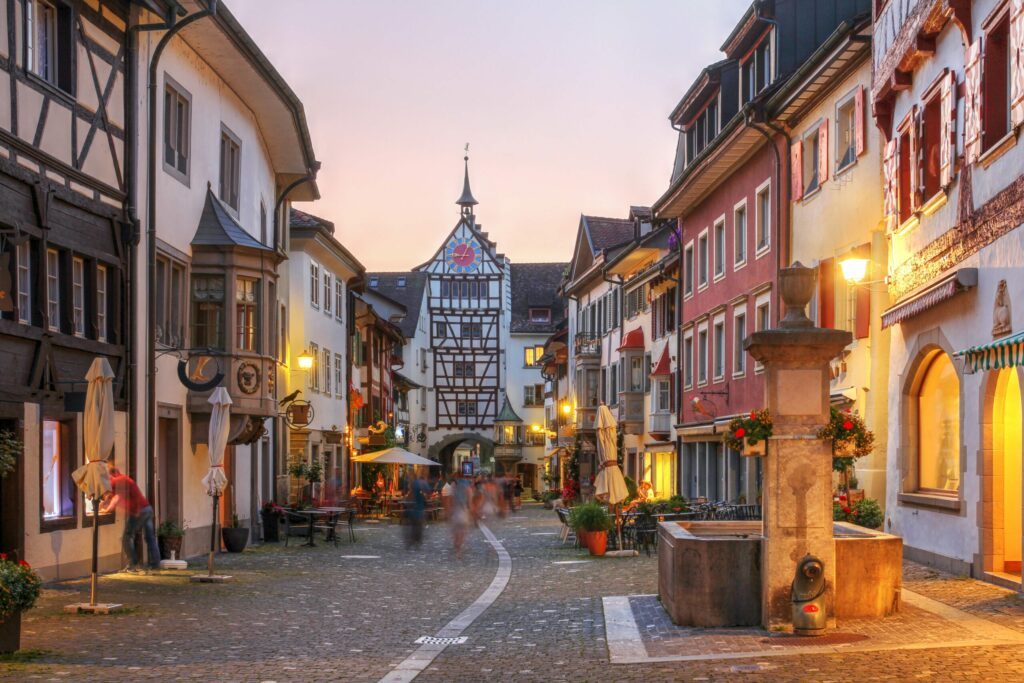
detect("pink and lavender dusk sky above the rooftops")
[228,0,750,270]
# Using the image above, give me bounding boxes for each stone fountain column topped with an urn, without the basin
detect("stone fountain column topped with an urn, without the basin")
[743,263,852,629]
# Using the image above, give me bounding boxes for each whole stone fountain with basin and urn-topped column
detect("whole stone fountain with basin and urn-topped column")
[658,263,902,630]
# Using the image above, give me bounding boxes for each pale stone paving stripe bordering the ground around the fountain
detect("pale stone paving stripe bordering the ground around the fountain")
[601,589,1024,665]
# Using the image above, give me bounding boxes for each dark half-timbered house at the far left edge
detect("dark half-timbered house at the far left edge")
[0,0,133,579]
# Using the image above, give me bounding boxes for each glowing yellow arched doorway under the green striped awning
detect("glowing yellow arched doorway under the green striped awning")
[982,368,1024,577]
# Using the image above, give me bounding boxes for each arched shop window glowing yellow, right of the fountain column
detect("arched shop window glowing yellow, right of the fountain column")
[916,352,961,493]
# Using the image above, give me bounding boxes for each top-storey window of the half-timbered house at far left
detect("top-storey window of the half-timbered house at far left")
[25,0,75,92]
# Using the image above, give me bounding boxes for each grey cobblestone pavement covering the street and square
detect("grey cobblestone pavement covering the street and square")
[6,507,1024,682]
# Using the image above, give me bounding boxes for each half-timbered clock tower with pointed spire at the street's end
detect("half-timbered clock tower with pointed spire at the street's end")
[417,158,511,473]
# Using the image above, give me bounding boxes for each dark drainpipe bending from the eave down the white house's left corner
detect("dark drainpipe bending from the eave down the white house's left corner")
[144,0,217,500]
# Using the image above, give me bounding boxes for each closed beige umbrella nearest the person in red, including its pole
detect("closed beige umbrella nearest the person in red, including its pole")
[71,358,114,605]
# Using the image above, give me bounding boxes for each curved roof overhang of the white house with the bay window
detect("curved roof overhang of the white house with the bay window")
[181,0,319,201]
